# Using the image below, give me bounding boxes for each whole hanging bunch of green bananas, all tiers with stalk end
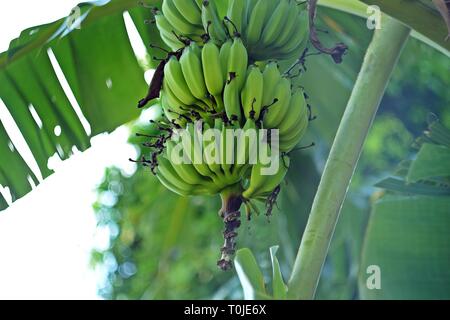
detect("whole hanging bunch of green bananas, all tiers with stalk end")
[139,0,310,269]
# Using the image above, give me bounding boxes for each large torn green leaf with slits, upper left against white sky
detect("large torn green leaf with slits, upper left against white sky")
[0,0,162,210]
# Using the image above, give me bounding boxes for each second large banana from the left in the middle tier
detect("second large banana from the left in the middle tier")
[180,42,208,101]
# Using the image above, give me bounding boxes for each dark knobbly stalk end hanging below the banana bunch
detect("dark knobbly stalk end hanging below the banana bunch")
[217,186,243,271]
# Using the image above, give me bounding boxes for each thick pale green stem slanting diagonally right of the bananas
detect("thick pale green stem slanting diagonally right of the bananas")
[288,15,410,299]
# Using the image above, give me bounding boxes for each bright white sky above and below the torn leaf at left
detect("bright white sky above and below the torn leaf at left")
[0,0,148,299]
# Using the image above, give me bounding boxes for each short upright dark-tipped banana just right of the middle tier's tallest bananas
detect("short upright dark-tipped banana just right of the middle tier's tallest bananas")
[241,66,264,119]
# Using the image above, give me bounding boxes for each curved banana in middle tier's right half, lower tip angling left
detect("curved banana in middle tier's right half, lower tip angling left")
[263,78,292,129]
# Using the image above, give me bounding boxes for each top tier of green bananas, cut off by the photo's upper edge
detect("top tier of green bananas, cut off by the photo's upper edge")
[155,0,309,61]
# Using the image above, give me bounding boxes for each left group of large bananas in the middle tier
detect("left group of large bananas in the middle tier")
[161,38,250,125]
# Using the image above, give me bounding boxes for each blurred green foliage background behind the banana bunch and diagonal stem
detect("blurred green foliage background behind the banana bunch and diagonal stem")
[93,10,450,299]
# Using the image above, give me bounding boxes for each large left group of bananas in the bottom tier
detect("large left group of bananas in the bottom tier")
[156,119,257,196]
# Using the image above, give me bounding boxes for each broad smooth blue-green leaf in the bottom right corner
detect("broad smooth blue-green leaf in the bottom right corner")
[359,196,450,300]
